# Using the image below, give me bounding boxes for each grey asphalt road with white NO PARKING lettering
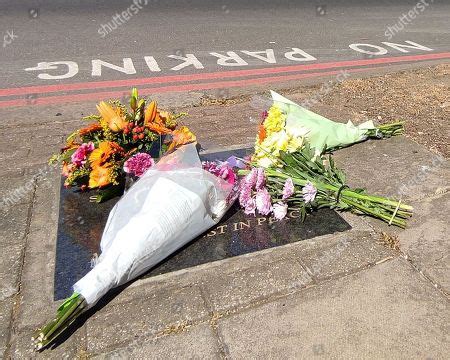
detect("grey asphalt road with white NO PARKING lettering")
[0,0,450,105]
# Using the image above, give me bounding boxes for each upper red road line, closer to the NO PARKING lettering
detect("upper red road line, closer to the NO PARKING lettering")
[0,52,450,96]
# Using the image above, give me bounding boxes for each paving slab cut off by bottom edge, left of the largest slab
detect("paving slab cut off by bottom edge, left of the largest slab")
[92,324,222,360]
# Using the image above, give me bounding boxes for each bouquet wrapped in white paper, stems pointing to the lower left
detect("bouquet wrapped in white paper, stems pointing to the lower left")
[33,144,236,350]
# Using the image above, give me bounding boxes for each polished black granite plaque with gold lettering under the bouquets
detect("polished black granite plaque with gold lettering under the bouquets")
[54,149,350,300]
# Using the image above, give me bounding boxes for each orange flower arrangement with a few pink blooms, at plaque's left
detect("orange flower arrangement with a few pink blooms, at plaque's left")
[50,88,196,202]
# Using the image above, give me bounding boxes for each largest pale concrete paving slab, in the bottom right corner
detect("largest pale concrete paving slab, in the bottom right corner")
[218,258,450,359]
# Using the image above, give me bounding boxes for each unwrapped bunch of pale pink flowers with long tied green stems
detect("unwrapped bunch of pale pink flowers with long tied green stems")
[239,142,413,228]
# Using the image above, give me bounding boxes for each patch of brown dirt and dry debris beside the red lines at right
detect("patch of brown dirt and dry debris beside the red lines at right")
[324,64,450,158]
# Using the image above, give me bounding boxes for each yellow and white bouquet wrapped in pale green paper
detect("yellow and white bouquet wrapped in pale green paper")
[254,91,403,167]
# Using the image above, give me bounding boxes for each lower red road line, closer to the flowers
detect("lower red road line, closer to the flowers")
[0,66,394,108]
